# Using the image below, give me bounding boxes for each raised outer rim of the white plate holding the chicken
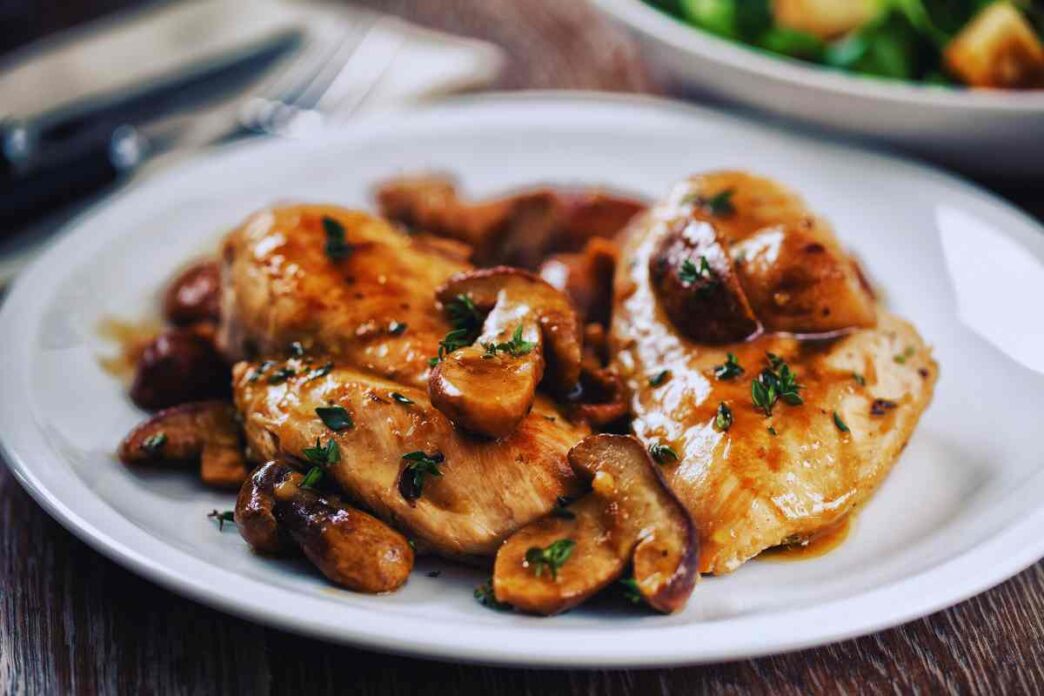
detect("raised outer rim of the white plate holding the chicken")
[0,92,1044,668]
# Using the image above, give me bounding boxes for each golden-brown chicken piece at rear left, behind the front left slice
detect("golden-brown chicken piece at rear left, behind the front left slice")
[218,206,470,386]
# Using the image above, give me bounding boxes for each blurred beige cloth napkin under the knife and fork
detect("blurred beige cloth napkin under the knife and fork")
[0,0,503,287]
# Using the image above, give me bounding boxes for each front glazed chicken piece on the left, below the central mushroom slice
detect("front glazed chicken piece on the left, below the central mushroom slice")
[234,358,589,556]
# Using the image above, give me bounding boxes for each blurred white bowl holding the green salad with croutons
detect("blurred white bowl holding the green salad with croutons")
[594,0,1044,178]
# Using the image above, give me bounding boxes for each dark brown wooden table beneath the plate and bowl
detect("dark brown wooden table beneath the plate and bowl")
[0,0,1044,695]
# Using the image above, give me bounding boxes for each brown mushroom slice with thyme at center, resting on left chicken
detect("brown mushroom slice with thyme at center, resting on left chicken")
[428,266,583,437]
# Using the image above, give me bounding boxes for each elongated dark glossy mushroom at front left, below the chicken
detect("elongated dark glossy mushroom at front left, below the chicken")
[236,461,413,594]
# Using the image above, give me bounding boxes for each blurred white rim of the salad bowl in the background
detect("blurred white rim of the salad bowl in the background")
[594,0,1044,113]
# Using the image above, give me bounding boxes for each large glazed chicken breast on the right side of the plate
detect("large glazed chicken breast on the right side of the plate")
[611,174,936,573]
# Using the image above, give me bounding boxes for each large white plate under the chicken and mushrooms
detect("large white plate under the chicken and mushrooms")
[0,95,1044,667]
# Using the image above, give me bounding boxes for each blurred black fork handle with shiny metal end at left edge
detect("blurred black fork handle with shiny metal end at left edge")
[0,123,148,224]
